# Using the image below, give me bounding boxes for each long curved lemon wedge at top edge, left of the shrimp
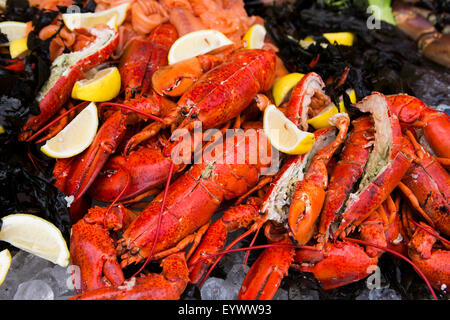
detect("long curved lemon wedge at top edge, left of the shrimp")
[62,2,130,31]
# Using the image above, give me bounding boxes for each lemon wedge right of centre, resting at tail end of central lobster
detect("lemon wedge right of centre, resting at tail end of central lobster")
[263,104,315,154]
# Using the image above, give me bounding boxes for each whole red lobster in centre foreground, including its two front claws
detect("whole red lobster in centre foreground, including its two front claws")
[70,124,272,299]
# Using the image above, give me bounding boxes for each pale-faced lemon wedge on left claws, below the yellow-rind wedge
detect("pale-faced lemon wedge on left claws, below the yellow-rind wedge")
[41,102,98,158]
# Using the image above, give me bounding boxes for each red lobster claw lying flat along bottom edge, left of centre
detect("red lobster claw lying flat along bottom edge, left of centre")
[70,252,189,300]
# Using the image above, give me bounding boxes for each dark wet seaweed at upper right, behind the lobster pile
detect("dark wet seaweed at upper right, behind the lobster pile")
[247,0,438,107]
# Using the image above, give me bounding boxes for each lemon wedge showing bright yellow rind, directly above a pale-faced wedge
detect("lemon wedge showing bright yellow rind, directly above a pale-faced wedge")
[72,67,121,102]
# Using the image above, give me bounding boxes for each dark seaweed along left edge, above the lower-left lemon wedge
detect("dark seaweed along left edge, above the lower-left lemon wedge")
[0,0,71,246]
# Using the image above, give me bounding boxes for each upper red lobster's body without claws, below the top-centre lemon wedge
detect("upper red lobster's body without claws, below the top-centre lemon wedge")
[178,49,276,130]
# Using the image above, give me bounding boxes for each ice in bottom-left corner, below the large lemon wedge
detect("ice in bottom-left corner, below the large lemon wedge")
[0,251,75,300]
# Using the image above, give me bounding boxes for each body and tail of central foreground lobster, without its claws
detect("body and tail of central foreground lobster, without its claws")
[118,126,272,266]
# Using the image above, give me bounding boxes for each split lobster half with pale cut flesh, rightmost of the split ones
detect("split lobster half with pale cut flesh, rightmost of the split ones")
[335,93,412,236]
